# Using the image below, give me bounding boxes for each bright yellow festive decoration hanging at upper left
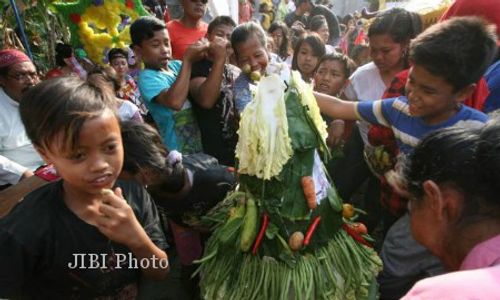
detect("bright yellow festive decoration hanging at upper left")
[52,0,148,64]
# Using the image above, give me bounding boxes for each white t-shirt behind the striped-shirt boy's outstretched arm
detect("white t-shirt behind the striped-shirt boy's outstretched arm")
[345,62,387,145]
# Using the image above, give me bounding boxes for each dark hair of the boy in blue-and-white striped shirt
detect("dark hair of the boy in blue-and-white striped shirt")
[410,17,497,91]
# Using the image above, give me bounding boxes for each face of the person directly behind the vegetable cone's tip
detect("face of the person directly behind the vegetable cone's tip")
[235,35,269,75]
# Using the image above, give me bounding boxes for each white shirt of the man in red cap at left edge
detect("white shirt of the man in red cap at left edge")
[0,88,44,185]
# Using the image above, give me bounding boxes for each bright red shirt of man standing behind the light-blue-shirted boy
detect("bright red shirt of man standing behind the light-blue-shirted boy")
[167,20,208,60]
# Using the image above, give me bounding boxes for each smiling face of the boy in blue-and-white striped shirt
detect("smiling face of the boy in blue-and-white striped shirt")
[406,65,468,125]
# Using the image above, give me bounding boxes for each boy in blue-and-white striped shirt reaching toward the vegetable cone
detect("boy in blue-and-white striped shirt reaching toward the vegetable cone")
[316,17,497,299]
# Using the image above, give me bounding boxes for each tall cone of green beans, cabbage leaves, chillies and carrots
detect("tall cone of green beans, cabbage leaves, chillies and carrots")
[198,72,382,300]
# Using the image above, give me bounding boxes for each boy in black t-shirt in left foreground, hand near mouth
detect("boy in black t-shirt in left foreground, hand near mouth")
[0,77,168,299]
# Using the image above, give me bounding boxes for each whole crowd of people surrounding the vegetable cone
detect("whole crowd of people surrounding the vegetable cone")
[0,0,500,299]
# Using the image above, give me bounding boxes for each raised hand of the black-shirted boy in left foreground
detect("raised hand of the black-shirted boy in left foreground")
[96,188,149,248]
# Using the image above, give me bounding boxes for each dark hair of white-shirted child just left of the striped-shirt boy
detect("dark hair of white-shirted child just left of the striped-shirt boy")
[368,7,422,43]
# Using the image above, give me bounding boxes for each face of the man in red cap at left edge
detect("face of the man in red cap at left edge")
[0,61,40,102]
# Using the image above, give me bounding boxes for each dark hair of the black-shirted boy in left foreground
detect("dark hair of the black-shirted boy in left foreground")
[19,76,116,152]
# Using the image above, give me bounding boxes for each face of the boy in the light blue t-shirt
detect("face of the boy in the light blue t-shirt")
[135,29,172,69]
